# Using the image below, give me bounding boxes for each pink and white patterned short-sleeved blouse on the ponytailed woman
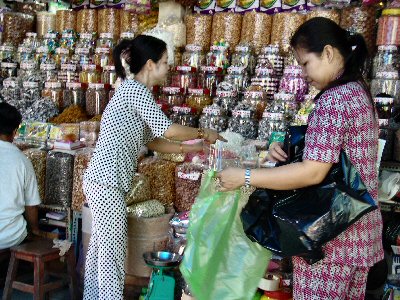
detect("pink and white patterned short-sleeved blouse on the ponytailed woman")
[303,82,383,267]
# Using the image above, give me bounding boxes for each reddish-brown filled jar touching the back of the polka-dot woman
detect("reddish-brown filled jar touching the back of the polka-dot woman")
[86,83,108,117]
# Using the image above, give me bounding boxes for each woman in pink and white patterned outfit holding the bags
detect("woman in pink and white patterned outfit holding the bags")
[219,18,383,300]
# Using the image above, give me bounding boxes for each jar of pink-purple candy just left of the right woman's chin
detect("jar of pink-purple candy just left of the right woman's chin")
[279,66,308,102]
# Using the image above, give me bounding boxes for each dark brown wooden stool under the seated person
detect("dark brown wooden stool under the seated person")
[3,240,78,300]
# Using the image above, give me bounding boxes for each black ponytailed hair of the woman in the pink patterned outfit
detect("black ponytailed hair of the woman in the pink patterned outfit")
[290,17,372,101]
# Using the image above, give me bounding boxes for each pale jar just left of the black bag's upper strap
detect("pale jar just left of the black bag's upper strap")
[257,111,287,142]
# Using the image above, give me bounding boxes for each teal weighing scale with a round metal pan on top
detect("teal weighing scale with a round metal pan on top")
[143,251,182,300]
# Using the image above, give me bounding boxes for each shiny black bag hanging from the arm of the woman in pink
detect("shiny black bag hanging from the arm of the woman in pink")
[241,126,377,263]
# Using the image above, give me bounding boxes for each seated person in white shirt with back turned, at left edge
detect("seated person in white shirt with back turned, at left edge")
[0,103,40,249]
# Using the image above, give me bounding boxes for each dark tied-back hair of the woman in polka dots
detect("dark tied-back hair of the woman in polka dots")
[113,35,167,79]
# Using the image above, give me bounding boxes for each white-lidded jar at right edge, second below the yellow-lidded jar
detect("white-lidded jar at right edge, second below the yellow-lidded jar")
[371,71,400,105]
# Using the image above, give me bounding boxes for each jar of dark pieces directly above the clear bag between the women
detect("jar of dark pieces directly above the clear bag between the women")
[228,105,258,139]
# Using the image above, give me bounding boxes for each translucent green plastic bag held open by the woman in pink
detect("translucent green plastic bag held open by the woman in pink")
[180,171,271,300]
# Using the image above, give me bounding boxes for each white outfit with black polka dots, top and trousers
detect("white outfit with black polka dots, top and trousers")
[84,80,171,300]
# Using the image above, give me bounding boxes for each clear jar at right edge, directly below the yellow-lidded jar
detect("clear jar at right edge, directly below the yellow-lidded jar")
[372,45,400,78]
